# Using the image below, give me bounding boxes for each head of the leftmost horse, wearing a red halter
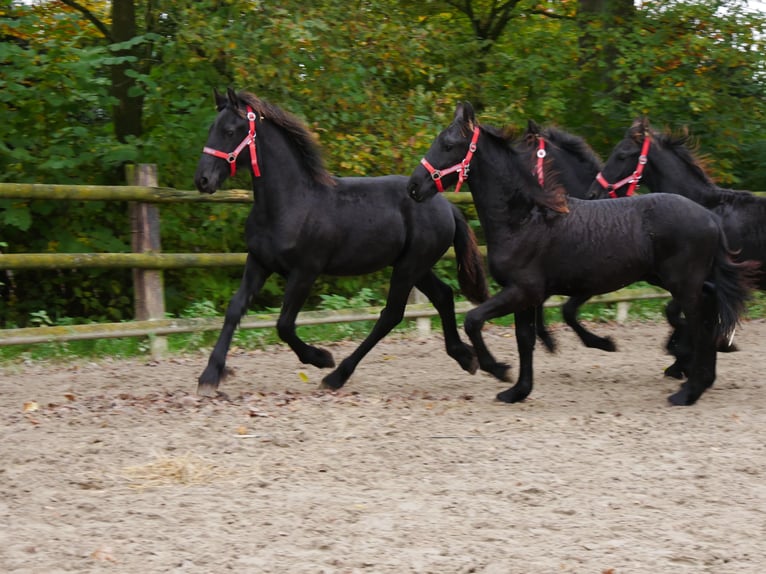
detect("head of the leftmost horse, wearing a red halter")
[194,88,260,193]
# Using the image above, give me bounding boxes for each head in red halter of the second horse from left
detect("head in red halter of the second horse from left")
[407,102,479,201]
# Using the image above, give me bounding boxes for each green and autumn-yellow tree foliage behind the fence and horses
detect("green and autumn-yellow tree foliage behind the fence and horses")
[0,0,766,324]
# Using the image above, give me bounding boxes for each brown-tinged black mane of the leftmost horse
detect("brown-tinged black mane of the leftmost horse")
[237,90,336,185]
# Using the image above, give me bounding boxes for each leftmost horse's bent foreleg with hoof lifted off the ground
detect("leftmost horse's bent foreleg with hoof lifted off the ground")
[277,270,335,369]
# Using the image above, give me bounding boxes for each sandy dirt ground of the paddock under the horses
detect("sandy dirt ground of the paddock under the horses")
[0,321,766,574]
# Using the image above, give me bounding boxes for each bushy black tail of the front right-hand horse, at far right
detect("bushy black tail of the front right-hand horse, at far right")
[712,237,761,340]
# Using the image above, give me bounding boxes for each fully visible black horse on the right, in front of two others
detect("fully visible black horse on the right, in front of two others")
[408,104,753,405]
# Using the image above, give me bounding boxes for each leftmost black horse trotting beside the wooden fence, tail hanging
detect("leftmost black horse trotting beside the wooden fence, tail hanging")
[194,89,488,394]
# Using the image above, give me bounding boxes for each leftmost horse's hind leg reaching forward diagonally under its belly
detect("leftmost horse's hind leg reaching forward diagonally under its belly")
[322,267,414,390]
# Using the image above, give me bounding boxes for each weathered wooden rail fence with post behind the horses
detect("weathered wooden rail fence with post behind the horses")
[0,171,668,356]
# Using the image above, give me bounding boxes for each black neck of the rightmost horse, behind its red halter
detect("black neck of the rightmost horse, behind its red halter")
[643,149,718,205]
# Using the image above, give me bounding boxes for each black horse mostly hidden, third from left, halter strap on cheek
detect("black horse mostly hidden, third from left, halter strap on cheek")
[514,120,617,352]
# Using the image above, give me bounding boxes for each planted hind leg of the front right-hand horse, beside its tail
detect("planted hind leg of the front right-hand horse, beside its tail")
[668,293,718,406]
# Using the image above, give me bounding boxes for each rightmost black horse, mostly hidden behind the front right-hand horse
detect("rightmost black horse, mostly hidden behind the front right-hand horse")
[590,118,766,378]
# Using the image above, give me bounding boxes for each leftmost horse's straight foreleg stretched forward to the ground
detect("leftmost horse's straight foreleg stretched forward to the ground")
[197,255,271,396]
